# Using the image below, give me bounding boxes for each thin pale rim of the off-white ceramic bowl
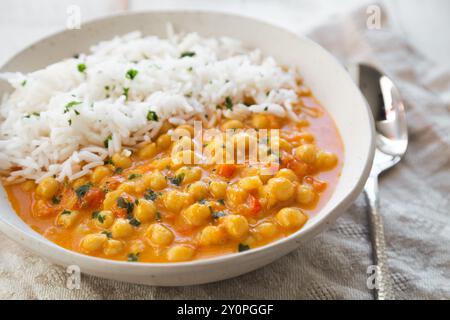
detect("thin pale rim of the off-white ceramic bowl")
[0,9,375,270]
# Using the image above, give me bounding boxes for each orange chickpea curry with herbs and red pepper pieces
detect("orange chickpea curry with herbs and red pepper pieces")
[6,92,343,262]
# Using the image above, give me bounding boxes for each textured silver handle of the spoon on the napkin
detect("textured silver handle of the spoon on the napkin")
[364,175,395,300]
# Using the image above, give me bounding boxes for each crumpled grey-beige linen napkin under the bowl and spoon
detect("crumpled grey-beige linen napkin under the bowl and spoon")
[0,6,450,299]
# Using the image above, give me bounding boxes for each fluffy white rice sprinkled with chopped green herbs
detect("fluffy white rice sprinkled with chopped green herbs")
[0,30,299,182]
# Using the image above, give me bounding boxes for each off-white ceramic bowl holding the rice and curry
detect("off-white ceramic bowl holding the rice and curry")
[0,11,374,286]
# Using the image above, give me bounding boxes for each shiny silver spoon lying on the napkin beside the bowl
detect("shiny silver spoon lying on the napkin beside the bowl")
[349,64,408,300]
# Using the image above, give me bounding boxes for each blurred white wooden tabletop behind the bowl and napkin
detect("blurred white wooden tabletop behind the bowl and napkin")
[0,0,450,68]
